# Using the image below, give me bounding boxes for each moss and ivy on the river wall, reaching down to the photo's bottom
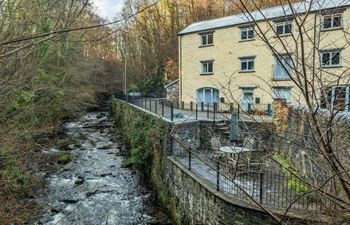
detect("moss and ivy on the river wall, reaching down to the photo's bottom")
[113,100,188,224]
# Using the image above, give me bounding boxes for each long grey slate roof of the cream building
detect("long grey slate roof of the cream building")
[178,0,350,35]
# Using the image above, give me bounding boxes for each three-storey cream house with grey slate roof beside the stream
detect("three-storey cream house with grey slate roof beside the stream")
[178,0,350,111]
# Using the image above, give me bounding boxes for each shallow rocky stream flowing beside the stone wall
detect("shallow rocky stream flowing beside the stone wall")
[36,112,170,225]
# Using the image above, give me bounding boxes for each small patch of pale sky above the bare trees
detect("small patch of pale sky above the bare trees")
[92,0,124,21]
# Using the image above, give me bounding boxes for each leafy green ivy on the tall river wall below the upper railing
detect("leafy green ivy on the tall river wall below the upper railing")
[114,100,168,178]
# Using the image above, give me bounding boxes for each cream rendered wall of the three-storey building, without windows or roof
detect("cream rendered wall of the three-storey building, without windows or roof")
[179,7,350,108]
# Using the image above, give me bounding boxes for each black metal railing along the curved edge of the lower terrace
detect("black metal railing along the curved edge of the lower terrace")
[172,143,339,213]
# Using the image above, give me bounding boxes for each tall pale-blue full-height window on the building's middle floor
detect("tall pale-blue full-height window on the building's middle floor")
[273,55,293,80]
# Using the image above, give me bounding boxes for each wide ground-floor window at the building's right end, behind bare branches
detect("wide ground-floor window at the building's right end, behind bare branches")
[320,86,350,112]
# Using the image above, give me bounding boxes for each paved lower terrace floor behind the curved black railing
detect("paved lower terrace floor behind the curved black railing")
[174,155,321,213]
